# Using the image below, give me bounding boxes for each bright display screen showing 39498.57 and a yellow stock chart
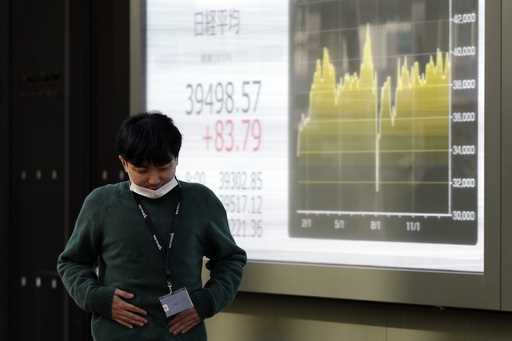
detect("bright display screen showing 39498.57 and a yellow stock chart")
[145,0,485,272]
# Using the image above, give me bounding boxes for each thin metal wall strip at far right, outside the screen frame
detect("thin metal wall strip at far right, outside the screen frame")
[501,0,512,311]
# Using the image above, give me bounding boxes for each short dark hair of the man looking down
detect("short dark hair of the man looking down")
[116,112,181,167]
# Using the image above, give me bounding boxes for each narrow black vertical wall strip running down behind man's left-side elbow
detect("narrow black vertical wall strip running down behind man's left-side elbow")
[62,0,93,341]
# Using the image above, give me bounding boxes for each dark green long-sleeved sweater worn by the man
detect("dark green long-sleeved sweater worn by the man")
[57,182,246,341]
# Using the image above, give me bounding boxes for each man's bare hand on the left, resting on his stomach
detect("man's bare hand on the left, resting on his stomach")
[112,289,148,328]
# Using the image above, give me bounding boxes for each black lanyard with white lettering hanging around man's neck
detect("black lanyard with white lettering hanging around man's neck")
[132,185,181,293]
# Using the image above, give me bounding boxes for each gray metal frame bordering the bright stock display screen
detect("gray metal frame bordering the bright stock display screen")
[131,1,501,310]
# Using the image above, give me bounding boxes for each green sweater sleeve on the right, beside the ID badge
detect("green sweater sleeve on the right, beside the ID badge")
[191,189,247,318]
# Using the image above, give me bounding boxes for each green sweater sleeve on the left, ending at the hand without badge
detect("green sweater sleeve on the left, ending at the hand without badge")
[57,192,114,318]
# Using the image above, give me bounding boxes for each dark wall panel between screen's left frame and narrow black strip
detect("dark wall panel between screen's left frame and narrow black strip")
[92,1,130,187]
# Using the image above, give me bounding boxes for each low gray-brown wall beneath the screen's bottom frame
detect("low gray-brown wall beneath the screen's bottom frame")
[207,293,512,341]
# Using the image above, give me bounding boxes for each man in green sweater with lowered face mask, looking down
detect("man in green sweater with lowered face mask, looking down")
[57,113,246,341]
